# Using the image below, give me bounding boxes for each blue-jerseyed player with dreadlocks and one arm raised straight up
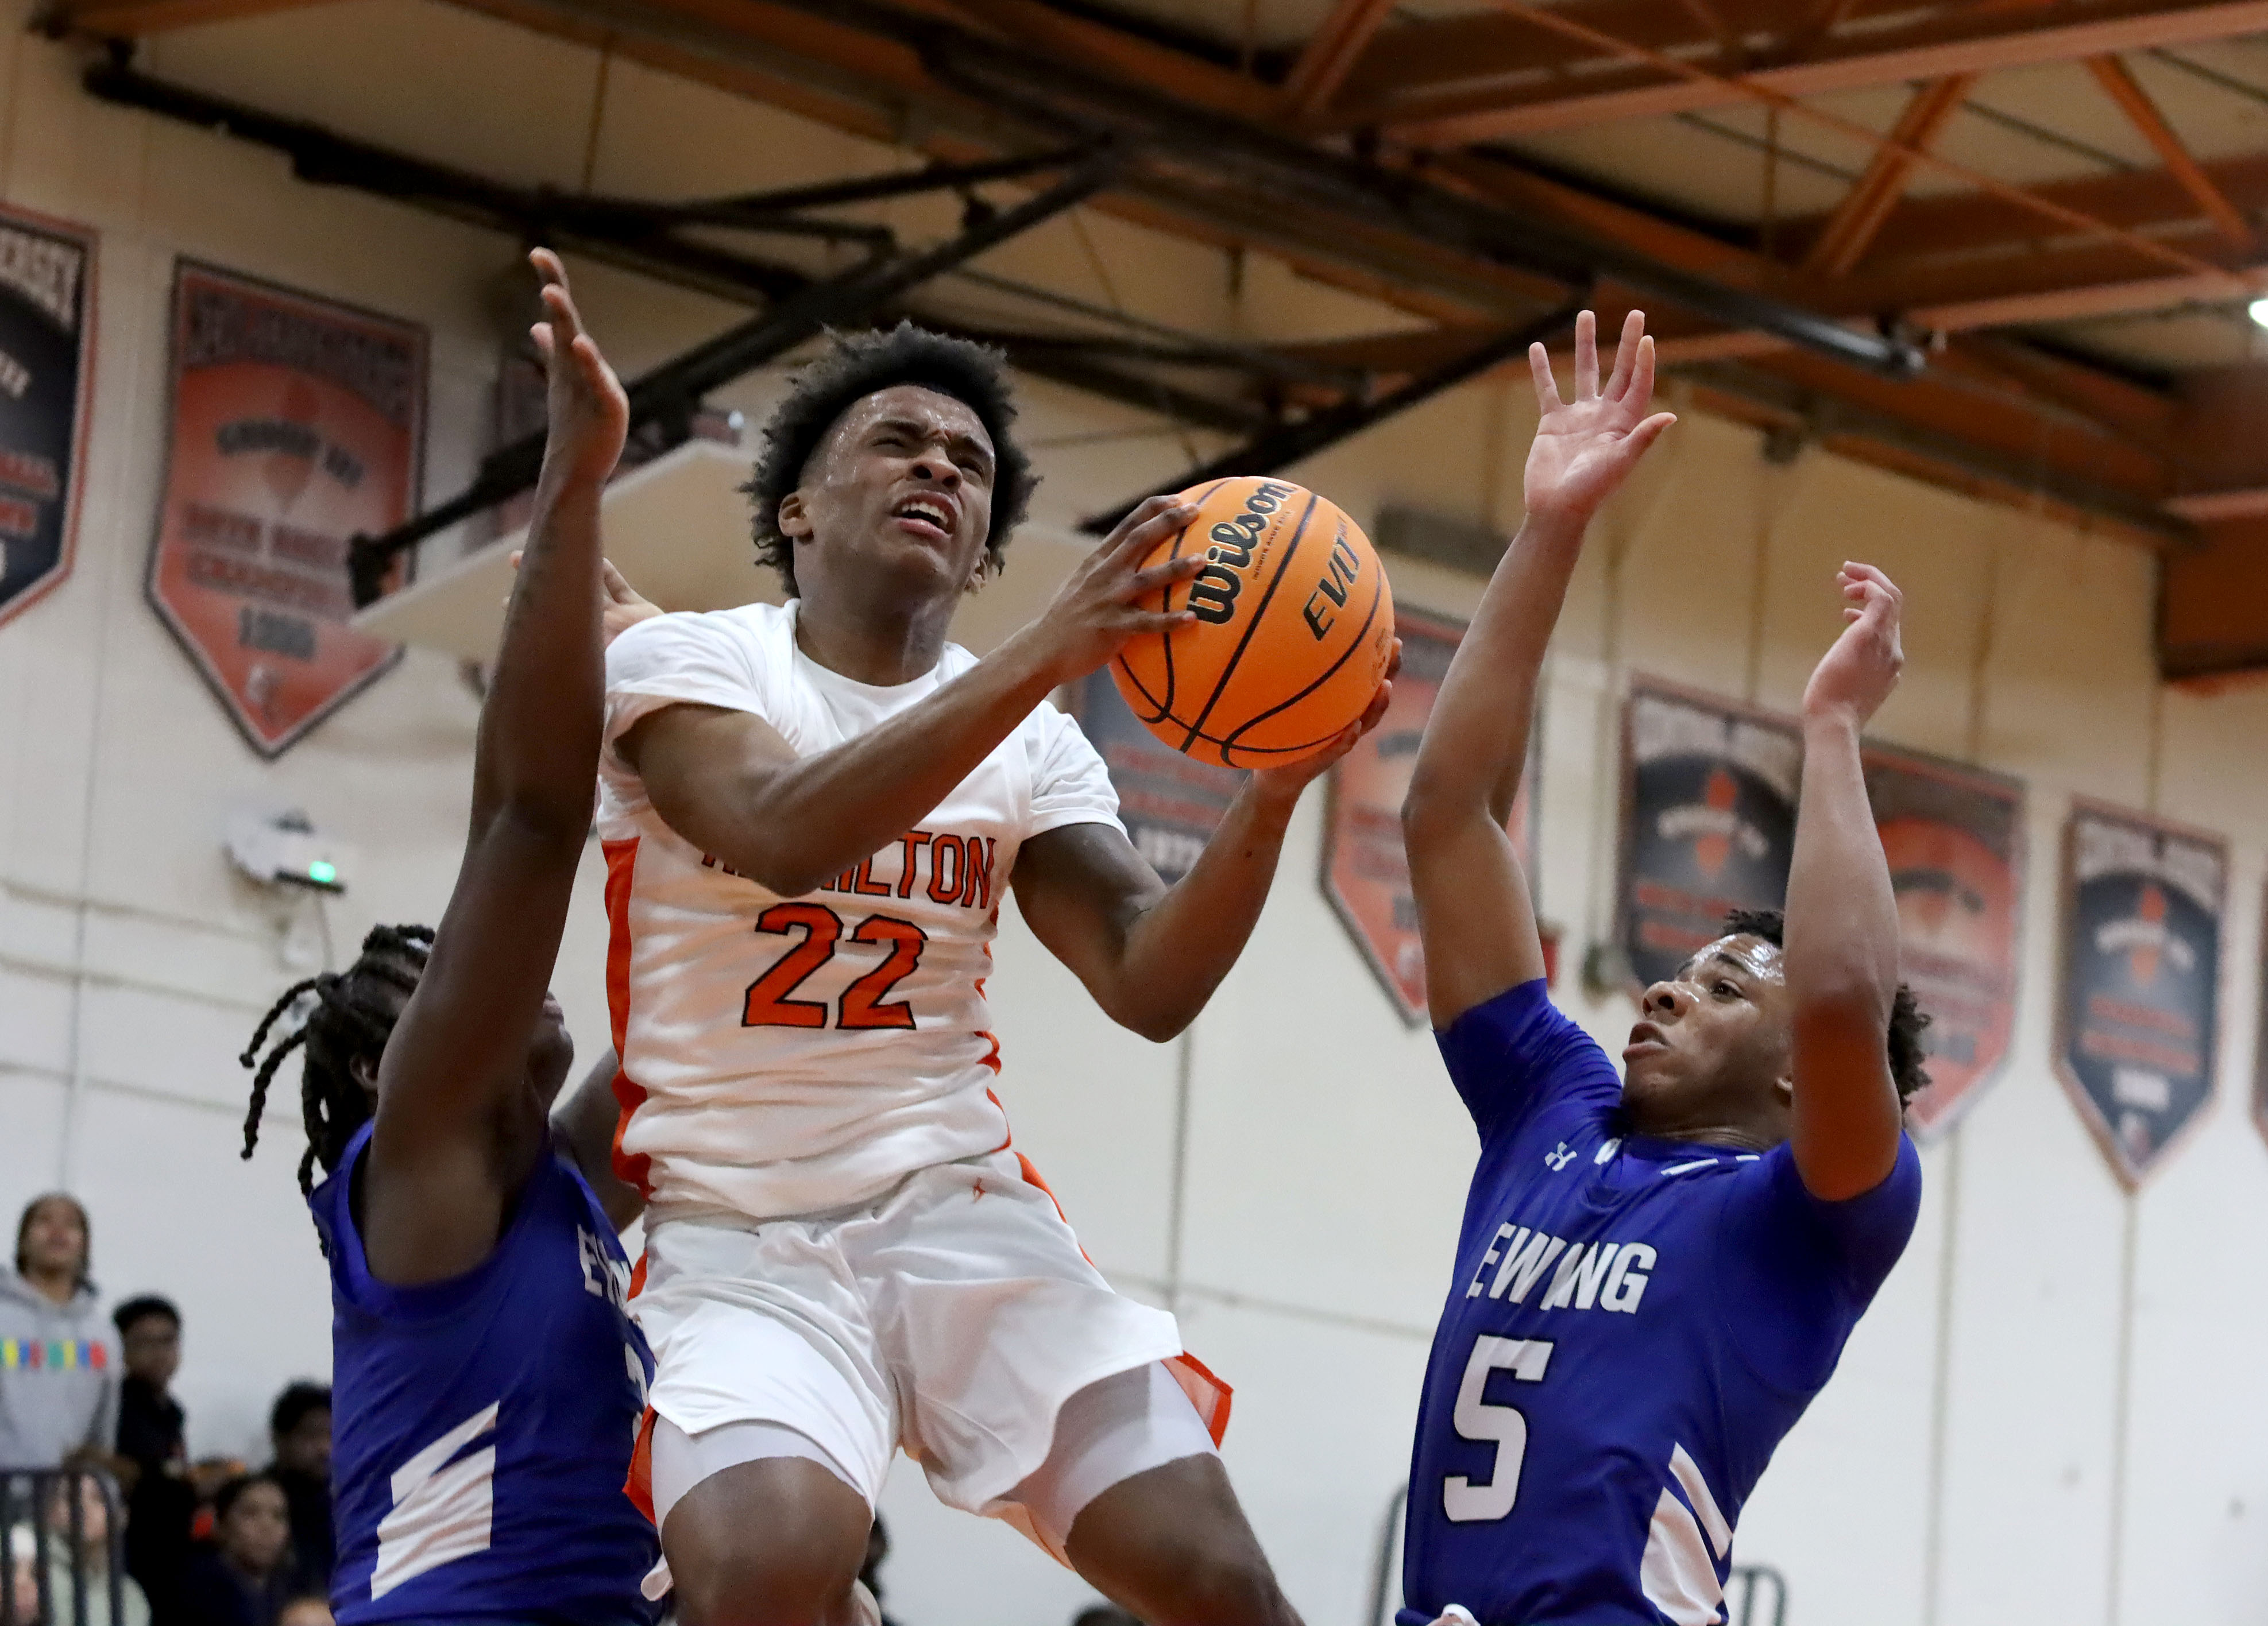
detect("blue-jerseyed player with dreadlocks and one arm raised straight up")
[245,251,658,1626]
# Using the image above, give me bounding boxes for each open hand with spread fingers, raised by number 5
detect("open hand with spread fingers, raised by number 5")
[1527,311,1678,524]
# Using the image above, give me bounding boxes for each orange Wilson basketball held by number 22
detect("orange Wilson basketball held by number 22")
[1111,478,1395,769]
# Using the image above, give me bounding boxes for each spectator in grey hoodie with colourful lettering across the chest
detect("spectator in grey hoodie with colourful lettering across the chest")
[0,1191,118,1468]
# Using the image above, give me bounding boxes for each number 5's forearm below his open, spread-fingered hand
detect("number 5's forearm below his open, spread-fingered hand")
[1401,515,1583,850]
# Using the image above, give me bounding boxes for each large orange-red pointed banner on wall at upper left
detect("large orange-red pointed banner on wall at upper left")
[148,261,426,757]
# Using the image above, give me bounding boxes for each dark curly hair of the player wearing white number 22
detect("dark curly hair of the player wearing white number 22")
[739,322,1039,597]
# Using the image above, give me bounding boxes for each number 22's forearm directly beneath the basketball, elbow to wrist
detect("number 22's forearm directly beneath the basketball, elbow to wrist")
[1104,780,1297,1041]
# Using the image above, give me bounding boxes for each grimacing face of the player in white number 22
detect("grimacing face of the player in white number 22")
[780,384,994,597]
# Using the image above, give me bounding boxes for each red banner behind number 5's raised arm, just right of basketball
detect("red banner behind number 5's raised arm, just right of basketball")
[1322,608,1556,1027]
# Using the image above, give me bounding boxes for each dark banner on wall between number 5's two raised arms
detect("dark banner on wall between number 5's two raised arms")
[1615,678,1803,989]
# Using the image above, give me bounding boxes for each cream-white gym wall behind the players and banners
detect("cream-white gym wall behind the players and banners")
[0,0,2268,1626]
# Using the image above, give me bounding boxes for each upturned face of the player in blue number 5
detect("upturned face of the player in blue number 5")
[1622,932,1790,1134]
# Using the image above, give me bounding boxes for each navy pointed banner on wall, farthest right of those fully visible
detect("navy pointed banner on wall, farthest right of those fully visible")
[2055,803,2227,1186]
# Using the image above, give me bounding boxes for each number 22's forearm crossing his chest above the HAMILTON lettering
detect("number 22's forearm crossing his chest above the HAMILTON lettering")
[689,640,1057,898]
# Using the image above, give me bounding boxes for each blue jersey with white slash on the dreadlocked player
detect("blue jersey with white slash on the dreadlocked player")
[308,1125,660,1626]
